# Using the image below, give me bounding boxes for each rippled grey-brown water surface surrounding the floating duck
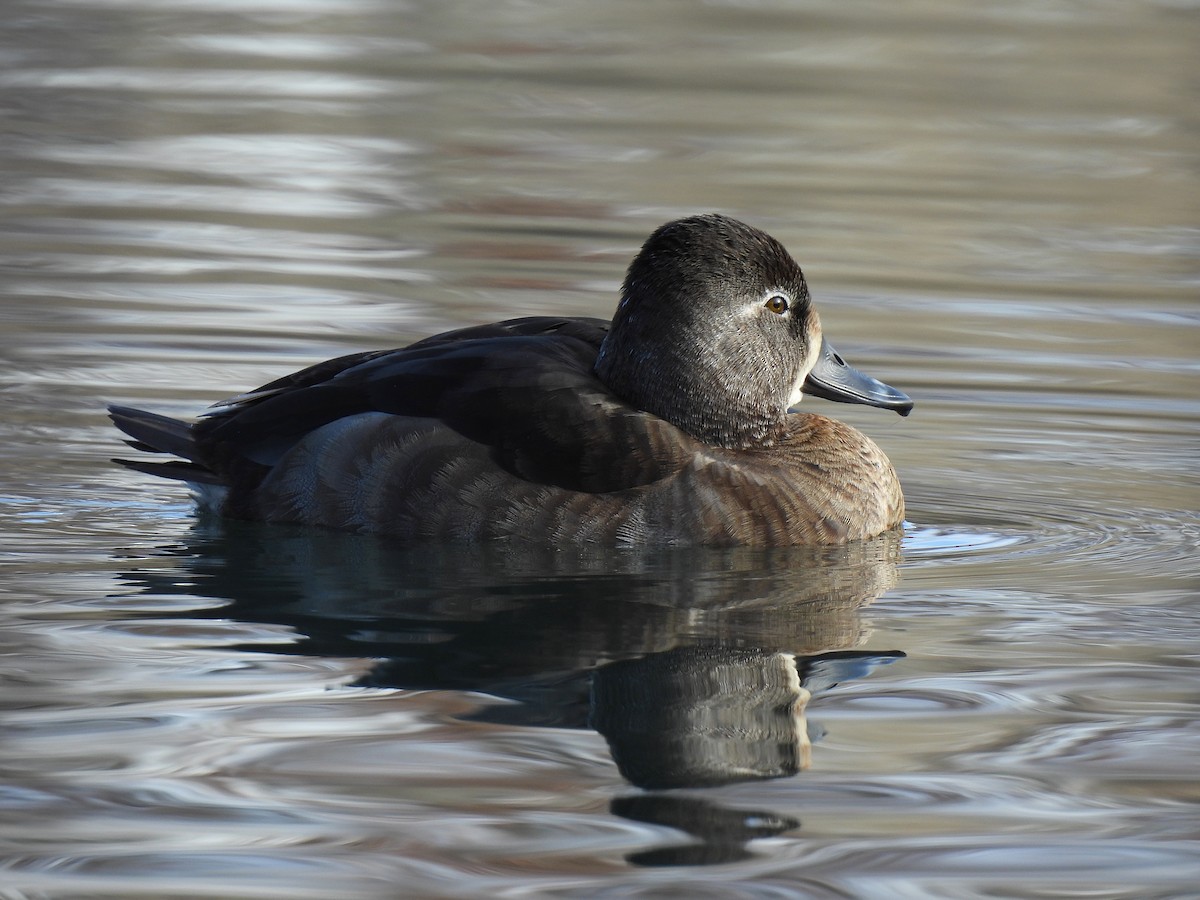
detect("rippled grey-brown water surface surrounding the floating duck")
[0,0,1200,900]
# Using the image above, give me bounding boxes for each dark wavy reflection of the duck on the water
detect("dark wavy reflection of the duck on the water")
[117,523,904,865]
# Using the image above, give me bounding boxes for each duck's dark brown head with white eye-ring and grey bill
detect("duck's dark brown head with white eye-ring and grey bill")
[595,214,912,448]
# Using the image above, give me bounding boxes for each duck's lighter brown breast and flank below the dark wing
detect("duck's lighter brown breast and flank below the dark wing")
[243,413,904,546]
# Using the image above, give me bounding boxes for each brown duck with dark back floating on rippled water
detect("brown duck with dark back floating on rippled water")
[109,214,913,547]
